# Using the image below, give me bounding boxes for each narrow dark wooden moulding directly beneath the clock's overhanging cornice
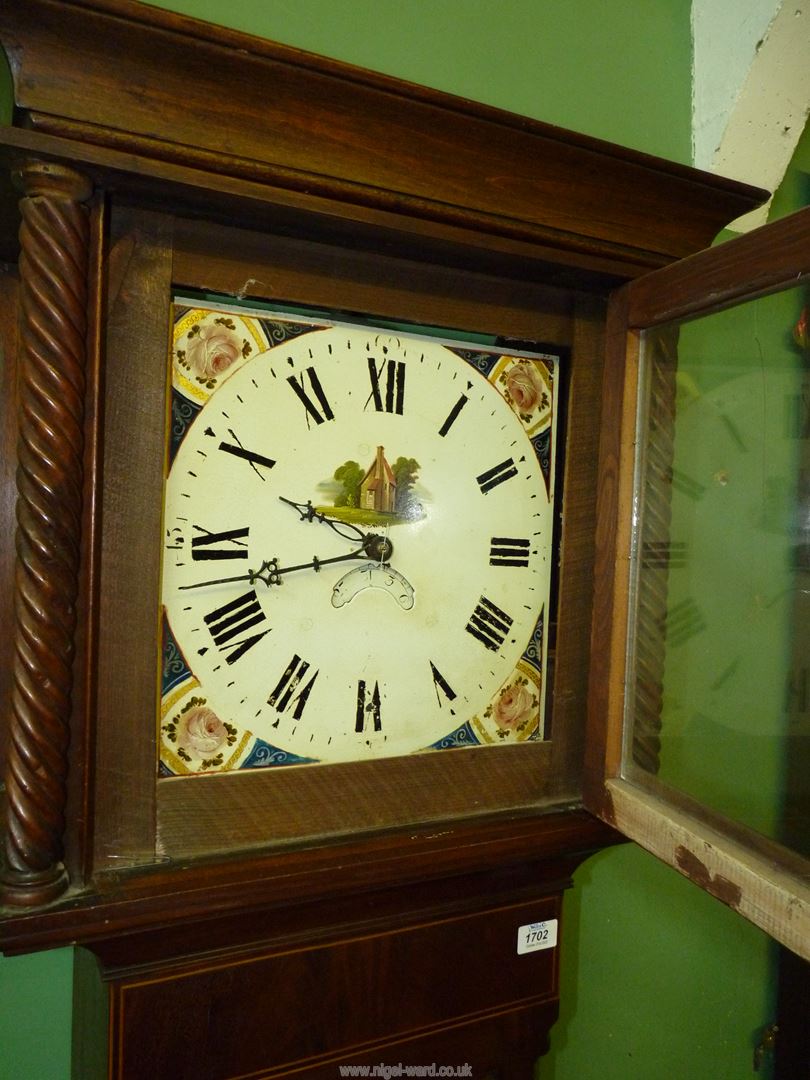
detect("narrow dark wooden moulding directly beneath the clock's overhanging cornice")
[0,122,670,292]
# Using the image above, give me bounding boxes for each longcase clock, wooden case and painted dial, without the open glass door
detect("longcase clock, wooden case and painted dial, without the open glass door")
[0,0,806,1078]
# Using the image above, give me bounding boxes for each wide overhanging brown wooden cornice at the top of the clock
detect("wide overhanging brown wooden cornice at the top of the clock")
[0,0,762,267]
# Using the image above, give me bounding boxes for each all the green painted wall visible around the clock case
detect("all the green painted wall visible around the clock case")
[0,0,804,1080]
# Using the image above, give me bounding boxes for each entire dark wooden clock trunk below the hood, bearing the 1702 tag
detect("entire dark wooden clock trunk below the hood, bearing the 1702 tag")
[75,872,561,1080]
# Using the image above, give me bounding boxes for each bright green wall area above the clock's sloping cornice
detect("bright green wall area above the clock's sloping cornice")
[144,0,691,162]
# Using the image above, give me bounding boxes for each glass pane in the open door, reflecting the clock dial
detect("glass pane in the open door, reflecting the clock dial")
[625,286,810,854]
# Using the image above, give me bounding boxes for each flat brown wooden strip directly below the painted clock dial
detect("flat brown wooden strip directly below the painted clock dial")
[157,743,557,859]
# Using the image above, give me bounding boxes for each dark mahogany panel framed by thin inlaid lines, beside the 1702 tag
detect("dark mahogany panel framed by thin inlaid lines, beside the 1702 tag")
[110,896,559,1080]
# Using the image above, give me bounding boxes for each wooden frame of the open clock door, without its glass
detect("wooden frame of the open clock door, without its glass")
[584,208,810,957]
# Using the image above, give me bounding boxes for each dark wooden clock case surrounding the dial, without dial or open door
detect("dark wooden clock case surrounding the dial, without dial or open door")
[0,0,764,1078]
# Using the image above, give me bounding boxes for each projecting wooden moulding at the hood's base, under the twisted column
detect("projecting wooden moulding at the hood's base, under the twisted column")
[0,810,622,954]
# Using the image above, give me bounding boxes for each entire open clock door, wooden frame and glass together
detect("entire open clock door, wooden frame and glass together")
[588,203,810,956]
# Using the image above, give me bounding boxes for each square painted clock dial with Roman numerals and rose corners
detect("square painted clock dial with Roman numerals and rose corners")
[161,307,556,774]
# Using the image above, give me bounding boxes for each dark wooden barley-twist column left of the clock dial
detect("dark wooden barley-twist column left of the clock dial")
[0,161,92,906]
